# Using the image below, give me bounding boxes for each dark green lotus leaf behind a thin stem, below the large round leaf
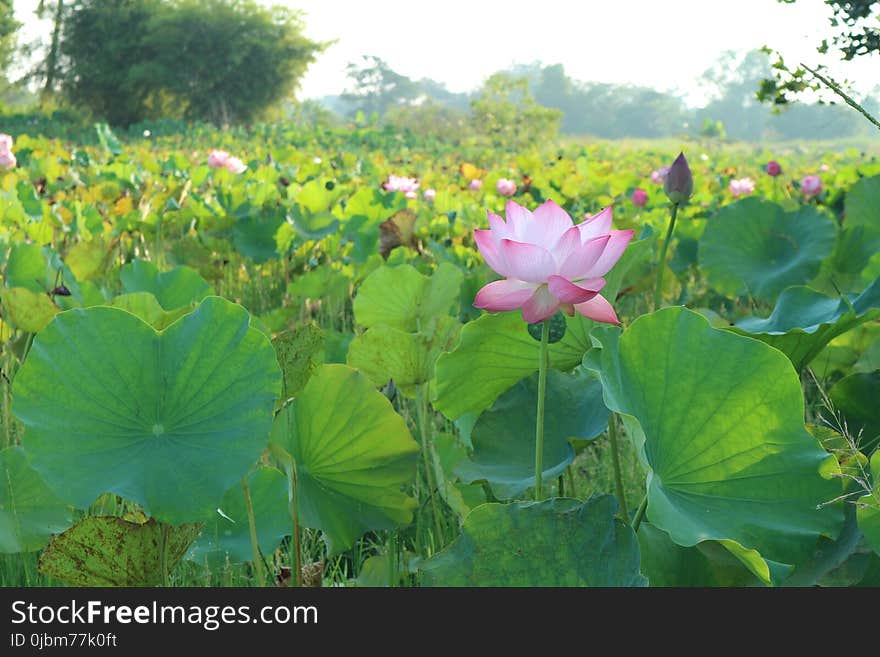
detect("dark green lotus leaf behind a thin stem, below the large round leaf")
[186,467,293,568]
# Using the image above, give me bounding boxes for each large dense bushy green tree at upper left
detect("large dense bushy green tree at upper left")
[60,0,324,125]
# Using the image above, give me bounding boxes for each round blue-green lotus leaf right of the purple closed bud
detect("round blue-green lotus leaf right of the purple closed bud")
[699,197,837,301]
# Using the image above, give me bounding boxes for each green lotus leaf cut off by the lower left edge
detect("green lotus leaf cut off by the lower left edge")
[0,447,71,553]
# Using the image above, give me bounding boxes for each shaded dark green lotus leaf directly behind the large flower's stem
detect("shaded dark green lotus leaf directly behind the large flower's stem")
[455,370,608,499]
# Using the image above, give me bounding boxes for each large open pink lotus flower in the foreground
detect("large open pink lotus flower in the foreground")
[474,201,633,324]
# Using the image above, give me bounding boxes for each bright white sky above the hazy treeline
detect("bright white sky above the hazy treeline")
[15,0,880,104]
